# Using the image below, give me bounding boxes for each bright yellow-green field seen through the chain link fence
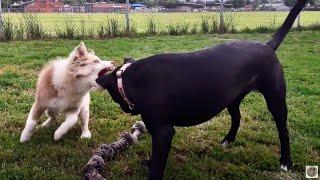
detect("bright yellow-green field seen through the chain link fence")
[4,11,320,34]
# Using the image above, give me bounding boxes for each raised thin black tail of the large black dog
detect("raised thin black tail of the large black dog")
[267,0,307,50]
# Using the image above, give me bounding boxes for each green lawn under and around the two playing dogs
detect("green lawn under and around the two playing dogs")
[0,31,320,179]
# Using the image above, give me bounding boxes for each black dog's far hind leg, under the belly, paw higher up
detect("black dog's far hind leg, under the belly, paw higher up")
[221,93,247,146]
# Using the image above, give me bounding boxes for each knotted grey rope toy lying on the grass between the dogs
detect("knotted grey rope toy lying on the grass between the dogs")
[83,121,147,180]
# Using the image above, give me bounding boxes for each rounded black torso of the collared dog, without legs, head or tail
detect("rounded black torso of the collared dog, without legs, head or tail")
[127,41,279,126]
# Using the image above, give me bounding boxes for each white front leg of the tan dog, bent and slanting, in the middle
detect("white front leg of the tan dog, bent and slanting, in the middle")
[54,111,79,141]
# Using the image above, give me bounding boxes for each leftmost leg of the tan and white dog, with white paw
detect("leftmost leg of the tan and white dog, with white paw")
[20,102,45,143]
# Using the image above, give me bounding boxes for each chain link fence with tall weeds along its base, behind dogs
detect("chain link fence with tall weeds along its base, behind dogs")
[0,0,320,40]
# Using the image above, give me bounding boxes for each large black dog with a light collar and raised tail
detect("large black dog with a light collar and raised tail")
[96,0,306,179]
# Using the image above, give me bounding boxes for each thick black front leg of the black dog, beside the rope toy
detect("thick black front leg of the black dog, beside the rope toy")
[148,126,175,180]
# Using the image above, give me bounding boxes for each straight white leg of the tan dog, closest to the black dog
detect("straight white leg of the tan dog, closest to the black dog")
[80,94,91,138]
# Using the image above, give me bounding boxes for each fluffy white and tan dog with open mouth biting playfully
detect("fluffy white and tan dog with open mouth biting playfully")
[20,43,114,142]
